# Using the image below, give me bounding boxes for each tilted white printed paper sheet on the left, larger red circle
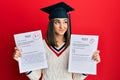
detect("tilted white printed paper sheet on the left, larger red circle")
[14,30,48,73]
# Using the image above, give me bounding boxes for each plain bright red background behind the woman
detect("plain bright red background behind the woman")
[0,0,120,80]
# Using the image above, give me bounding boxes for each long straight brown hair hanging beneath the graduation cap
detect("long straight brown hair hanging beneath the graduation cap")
[46,19,70,47]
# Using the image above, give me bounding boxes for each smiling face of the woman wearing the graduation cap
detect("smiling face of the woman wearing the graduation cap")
[53,18,68,36]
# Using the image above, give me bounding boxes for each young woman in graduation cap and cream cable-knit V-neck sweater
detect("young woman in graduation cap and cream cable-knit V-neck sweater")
[14,2,100,80]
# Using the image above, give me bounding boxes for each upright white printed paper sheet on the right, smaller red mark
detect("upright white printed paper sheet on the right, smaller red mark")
[68,34,98,75]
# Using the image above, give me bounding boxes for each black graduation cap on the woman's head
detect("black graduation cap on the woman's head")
[41,2,74,19]
